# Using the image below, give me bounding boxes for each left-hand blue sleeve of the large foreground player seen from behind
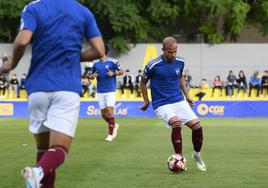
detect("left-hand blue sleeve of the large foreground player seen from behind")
[20,4,37,33]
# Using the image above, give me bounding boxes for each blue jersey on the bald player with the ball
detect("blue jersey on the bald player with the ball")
[143,56,184,110]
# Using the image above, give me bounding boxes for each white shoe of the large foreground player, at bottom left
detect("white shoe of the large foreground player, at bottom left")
[21,167,42,188]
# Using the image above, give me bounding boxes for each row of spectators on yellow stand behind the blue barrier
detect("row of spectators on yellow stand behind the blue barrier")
[0,53,268,100]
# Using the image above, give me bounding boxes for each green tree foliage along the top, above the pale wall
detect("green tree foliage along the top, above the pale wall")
[0,0,268,53]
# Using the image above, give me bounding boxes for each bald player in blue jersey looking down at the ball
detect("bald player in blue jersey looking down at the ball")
[140,37,206,171]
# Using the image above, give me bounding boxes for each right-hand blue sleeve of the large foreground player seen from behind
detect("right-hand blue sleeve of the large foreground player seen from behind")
[85,8,101,39]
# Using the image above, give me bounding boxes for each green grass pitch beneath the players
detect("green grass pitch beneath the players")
[0,118,268,188]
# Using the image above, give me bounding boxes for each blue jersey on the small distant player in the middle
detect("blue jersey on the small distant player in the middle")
[92,58,120,93]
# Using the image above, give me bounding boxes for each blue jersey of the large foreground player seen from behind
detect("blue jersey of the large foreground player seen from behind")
[20,0,101,94]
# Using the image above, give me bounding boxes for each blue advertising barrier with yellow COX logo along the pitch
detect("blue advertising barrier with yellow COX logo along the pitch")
[0,101,268,118]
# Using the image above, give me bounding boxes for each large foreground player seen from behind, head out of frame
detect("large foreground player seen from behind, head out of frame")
[0,0,104,188]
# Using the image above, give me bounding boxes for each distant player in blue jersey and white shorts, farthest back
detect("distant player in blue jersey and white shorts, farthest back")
[92,45,124,142]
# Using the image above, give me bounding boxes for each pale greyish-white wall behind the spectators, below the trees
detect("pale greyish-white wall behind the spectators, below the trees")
[0,43,268,84]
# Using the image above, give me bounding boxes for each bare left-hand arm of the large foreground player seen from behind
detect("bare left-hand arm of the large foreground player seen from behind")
[1,30,33,72]
